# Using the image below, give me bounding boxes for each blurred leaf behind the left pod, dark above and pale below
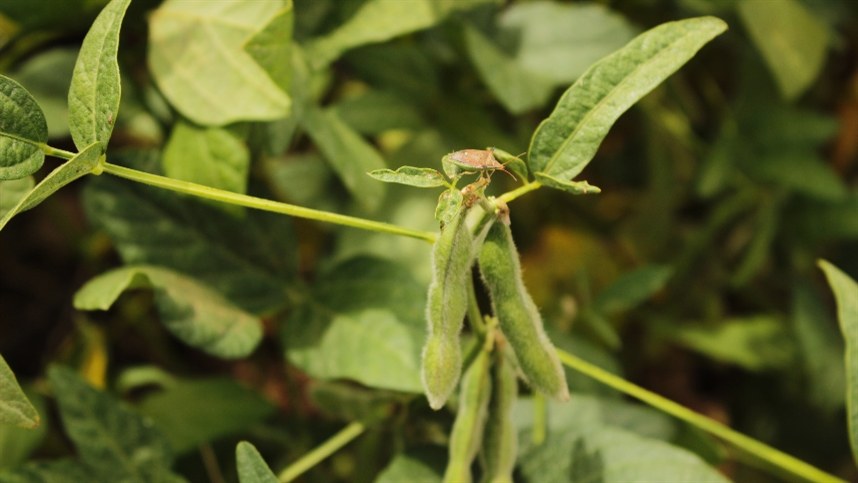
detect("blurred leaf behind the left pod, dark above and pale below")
[282,257,426,393]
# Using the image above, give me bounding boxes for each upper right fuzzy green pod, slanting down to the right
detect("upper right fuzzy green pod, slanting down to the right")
[479,223,569,400]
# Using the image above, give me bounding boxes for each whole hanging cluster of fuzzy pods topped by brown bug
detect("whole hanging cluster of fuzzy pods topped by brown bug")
[370,148,569,482]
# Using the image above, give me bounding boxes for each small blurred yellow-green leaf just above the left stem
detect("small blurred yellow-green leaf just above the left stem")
[163,121,250,198]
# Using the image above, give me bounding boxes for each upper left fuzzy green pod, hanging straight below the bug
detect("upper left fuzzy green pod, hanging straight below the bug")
[422,206,473,409]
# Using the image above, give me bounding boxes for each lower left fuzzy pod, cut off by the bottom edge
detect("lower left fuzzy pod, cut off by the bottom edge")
[443,347,491,483]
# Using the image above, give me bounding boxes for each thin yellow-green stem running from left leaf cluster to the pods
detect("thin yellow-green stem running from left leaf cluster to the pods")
[104,163,435,243]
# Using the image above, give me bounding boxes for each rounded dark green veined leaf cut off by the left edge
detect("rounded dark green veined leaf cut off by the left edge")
[0,75,48,180]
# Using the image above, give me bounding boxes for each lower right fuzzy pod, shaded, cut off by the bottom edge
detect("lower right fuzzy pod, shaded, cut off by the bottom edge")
[480,344,518,483]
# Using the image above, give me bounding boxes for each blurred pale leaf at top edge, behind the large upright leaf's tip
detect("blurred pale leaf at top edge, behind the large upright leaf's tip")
[498,1,634,84]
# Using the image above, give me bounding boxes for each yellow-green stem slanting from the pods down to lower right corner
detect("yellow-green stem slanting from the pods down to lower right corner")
[557,350,843,482]
